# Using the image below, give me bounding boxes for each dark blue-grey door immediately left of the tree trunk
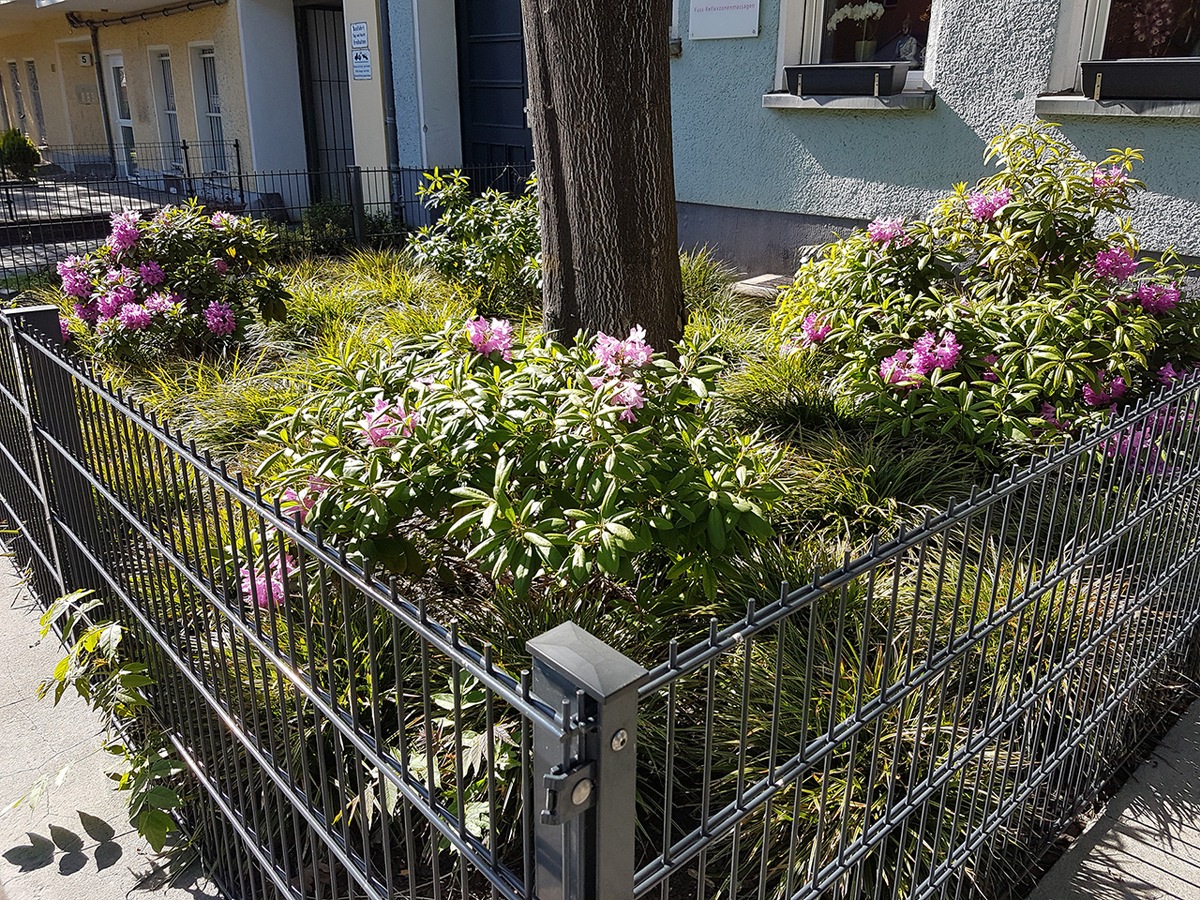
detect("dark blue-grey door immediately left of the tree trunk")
[453,0,533,187]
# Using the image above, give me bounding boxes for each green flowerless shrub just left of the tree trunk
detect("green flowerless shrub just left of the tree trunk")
[410,169,541,310]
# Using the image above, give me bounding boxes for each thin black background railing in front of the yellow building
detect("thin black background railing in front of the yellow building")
[0,158,532,290]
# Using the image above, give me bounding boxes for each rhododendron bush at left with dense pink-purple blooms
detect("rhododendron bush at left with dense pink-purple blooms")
[58,200,287,360]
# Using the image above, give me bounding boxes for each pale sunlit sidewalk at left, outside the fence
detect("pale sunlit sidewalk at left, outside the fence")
[0,558,220,900]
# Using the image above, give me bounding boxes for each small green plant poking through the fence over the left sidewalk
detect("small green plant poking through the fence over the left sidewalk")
[37,592,184,853]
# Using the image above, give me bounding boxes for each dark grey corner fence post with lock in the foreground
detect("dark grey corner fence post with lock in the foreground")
[526,622,646,900]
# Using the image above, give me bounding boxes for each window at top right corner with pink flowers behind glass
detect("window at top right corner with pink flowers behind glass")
[1048,0,1200,92]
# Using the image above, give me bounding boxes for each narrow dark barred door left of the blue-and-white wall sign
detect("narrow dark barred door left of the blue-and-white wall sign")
[296,6,354,202]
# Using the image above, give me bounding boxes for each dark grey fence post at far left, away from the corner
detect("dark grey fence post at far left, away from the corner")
[4,306,103,593]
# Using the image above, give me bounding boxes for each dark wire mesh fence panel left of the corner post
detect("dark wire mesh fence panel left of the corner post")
[0,310,566,900]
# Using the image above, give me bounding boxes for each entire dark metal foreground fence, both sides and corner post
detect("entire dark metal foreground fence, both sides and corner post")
[0,301,1200,900]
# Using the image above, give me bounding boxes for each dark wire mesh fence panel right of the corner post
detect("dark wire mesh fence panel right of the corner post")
[635,379,1200,900]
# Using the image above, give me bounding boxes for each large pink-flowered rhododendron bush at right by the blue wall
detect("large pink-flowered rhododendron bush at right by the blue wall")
[775,126,1200,458]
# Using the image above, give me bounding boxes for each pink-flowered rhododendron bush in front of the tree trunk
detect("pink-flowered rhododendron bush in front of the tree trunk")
[260,318,780,598]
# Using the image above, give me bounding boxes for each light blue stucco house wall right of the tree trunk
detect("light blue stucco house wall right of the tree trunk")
[671,0,1200,254]
